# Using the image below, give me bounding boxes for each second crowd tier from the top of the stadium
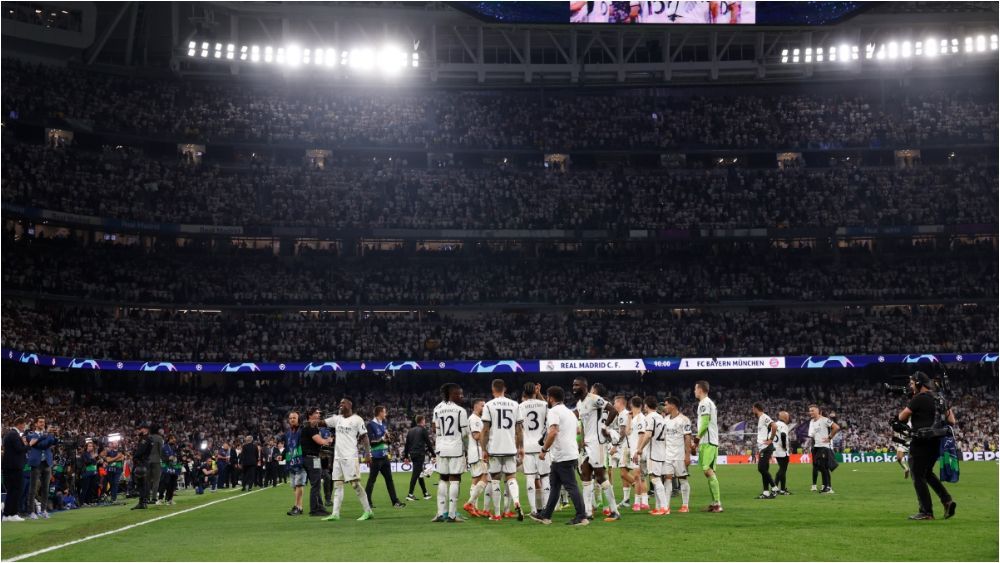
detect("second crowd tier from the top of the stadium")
[2,142,1000,228]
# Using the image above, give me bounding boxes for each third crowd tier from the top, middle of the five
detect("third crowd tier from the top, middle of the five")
[3,236,998,306]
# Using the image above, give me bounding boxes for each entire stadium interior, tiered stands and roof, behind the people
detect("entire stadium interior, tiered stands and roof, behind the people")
[2,1,1000,560]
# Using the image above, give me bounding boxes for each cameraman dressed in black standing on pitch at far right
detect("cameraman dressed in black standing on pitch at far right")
[899,371,955,520]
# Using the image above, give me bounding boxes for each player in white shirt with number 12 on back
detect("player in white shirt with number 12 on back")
[432,383,469,522]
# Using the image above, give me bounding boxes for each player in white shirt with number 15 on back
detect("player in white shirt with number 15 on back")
[479,379,524,521]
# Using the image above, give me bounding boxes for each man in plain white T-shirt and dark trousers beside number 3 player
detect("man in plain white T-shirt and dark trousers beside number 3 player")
[530,386,590,526]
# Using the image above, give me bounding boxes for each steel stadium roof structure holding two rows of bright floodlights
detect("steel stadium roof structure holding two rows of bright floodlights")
[3,1,997,86]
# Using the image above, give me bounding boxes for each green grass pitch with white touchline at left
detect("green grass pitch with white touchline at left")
[0,463,1000,561]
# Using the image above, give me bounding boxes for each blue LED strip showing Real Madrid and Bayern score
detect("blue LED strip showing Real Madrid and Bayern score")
[2,348,997,373]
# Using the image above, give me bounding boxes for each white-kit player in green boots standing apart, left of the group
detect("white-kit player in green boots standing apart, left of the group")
[323,396,375,521]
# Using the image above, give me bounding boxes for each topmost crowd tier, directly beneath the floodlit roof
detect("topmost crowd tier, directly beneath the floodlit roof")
[3,61,997,151]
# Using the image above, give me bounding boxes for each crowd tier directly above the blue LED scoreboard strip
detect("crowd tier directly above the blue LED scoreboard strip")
[2,302,998,362]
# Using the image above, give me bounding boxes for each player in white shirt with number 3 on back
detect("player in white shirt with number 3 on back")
[517,383,550,514]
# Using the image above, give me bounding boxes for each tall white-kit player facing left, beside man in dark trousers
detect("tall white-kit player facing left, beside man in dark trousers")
[573,377,621,522]
